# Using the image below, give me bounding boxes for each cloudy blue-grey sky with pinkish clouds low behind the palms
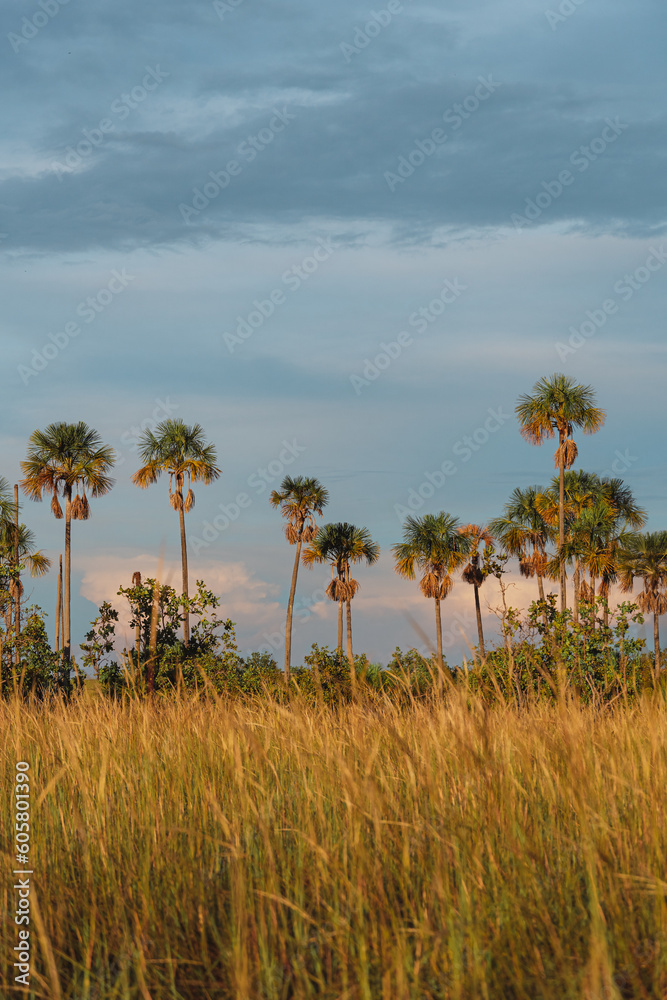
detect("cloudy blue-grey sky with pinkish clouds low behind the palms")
[0,0,667,663]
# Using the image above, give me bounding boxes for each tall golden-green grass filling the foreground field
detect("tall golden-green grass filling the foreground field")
[0,693,667,1000]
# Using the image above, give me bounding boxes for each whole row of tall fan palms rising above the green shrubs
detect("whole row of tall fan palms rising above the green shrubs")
[0,373,667,692]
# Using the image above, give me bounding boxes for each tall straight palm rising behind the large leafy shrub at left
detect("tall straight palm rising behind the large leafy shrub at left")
[132,419,220,646]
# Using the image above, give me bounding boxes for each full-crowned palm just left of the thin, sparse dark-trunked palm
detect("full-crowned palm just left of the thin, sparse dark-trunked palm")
[392,511,471,671]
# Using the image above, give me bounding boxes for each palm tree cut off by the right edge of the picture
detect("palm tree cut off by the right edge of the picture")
[618,531,667,684]
